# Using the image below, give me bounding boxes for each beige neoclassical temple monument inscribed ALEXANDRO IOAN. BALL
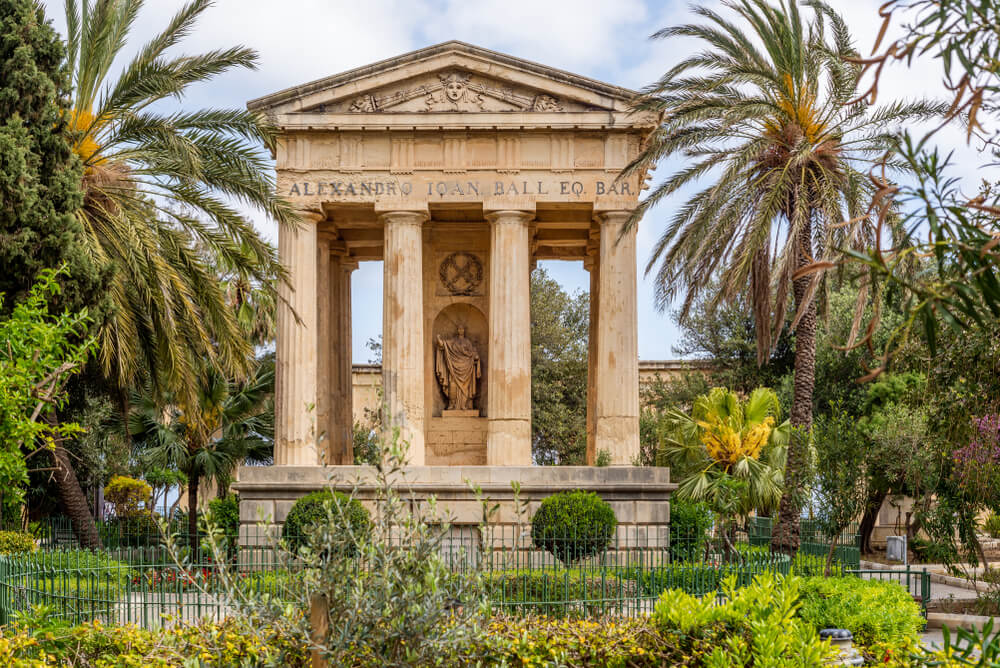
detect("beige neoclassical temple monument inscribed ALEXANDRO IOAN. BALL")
[239,42,671,544]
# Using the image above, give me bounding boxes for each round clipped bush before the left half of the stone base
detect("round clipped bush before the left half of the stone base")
[281,489,371,554]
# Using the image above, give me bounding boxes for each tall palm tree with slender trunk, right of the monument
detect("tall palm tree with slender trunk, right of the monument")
[626,0,940,551]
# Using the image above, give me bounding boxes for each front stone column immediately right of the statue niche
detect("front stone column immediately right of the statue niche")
[486,209,535,466]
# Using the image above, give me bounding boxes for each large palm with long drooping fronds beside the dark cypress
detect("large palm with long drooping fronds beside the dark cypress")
[51,0,294,536]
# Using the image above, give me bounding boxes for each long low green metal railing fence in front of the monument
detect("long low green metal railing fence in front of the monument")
[0,526,868,627]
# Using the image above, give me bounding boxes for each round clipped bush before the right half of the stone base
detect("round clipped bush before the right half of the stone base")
[531,490,618,564]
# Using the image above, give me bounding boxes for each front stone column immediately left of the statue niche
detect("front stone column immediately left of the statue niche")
[376,205,428,466]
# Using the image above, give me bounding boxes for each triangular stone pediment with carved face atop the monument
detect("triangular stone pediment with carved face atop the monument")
[247,42,635,114]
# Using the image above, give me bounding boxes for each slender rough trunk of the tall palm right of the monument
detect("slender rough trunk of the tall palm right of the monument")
[771,217,816,554]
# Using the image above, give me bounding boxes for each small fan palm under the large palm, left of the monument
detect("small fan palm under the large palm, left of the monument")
[128,355,274,536]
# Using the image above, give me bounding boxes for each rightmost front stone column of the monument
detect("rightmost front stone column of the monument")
[594,210,639,466]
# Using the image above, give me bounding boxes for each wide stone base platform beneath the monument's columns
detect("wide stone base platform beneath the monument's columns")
[235,466,677,548]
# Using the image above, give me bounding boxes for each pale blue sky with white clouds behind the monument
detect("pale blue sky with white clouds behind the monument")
[43,0,985,362]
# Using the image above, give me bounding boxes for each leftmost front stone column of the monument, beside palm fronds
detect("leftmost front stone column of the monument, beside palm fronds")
[274,211,324,466]
